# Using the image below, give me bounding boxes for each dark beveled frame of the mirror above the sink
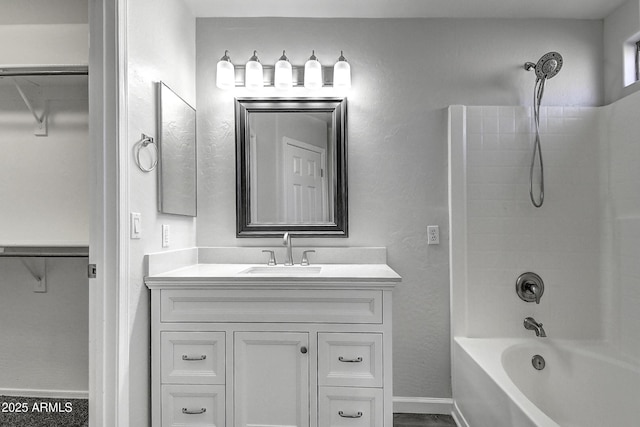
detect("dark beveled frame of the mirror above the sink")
[235,97,349,237]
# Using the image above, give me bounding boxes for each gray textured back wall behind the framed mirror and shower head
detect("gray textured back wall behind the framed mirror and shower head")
[196,18,604,397]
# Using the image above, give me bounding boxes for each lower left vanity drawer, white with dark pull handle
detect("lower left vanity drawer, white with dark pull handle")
[162,385,225,427]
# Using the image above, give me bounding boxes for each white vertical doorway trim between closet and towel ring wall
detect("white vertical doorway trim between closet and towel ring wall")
[89,0,129,427]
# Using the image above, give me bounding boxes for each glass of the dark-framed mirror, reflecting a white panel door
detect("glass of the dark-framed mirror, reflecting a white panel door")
[248,112,333,224]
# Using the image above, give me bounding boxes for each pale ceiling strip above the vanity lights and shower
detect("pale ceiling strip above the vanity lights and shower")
[184,0,626,19]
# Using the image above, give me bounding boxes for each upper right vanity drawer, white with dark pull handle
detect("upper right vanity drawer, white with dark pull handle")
[318,333,382,387]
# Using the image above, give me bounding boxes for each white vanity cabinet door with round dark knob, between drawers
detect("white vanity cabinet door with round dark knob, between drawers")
[233,332,309,427]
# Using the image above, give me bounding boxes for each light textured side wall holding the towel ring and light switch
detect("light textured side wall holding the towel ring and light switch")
[127,0,195,426]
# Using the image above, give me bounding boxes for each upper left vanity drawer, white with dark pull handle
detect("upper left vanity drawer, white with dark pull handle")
[160,331,225,384]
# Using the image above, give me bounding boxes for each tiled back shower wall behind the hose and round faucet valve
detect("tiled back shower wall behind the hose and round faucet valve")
[452,107,604,339]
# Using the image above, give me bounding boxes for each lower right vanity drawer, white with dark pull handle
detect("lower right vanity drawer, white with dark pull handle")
[318,387,384,427]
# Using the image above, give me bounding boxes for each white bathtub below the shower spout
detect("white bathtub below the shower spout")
[453,338,640,427]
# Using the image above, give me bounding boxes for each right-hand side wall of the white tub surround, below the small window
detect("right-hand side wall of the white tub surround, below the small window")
[602,93,640,361]
